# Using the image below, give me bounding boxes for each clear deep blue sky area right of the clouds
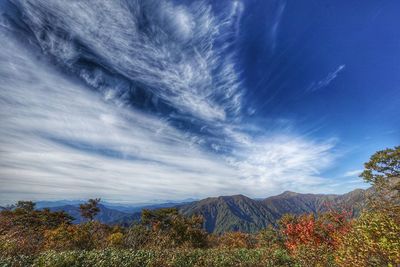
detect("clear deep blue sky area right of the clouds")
[240,1,400,186]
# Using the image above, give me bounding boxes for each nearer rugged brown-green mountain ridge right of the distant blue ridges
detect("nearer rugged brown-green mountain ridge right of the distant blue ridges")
[179,189,370,234]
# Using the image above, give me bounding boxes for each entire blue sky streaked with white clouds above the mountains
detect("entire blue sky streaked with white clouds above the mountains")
[0,0,400,204]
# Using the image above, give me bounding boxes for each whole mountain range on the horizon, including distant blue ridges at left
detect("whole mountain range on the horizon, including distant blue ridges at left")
[32,189,371,234]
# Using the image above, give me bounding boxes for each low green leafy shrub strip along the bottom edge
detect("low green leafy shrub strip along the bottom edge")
[0,248,294,267]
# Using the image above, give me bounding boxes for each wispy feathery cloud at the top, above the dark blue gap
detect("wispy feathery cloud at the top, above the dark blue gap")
[16,0,241,121]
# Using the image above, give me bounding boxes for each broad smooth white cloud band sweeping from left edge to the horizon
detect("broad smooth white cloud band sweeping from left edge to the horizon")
[0,29,241,204]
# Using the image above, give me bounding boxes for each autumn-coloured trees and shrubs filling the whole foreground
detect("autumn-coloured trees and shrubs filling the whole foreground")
[0,147,400,266]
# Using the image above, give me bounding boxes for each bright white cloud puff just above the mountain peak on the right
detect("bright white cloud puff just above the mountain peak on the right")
[225,134,336,197]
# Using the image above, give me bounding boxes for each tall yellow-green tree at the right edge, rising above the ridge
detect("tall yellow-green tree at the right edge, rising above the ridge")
[336,146,400,266]
